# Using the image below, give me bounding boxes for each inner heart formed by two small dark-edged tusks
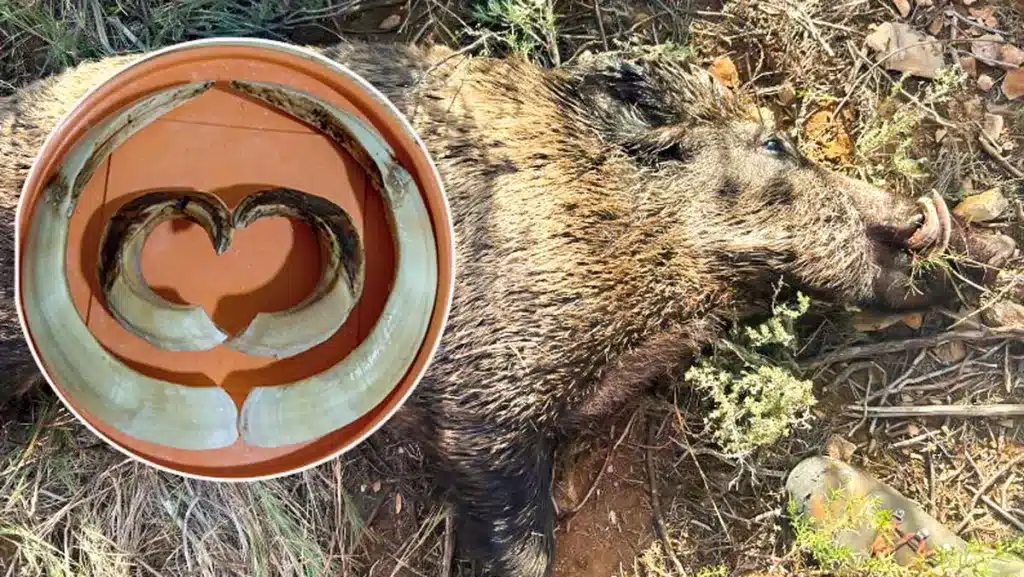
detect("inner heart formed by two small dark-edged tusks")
[98,188,365,359]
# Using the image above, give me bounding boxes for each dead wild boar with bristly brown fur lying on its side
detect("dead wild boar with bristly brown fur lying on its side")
[0,38,1015,577]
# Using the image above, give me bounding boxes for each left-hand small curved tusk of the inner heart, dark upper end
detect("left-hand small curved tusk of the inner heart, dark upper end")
[99,192,232,351]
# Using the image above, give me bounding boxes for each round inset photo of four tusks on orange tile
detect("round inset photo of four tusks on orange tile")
[15,38,455,481]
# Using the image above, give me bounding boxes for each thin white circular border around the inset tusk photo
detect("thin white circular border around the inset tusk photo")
[14,36,456,483]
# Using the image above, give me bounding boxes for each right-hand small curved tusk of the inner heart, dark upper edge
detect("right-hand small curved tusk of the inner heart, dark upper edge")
[226,189,364,359]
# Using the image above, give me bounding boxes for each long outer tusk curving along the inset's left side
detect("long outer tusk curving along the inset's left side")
[22,82,238,450]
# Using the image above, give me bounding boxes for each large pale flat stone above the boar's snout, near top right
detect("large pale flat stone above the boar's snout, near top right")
[864,23,945,78]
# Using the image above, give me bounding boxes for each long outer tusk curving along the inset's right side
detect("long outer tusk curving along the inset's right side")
[231,81,438,447]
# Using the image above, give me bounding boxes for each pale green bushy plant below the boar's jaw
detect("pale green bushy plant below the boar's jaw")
[685,294,817,457]
